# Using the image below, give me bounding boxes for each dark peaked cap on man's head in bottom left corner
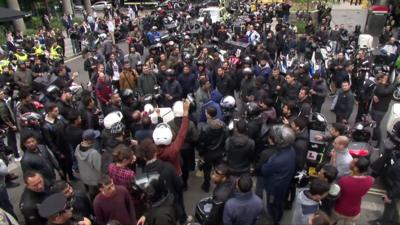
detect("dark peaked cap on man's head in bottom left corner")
[39,193,70,218]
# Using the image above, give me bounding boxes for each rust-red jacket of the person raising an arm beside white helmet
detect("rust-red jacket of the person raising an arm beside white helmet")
[157,116,189,176]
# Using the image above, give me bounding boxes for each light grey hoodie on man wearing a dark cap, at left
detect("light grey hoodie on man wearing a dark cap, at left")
[75,142,101,186]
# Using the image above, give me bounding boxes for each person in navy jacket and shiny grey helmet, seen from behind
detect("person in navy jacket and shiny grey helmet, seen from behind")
[261,125,296,225]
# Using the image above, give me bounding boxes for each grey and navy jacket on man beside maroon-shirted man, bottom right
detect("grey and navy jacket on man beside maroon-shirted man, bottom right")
[292,189,319,225]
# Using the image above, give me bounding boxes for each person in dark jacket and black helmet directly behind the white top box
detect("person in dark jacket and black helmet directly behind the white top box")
[161,69,182,107]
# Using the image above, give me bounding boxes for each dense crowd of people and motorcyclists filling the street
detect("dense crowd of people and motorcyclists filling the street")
[0,0,400,225]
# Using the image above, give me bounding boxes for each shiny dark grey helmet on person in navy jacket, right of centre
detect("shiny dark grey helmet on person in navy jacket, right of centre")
[269,125,296,148]
